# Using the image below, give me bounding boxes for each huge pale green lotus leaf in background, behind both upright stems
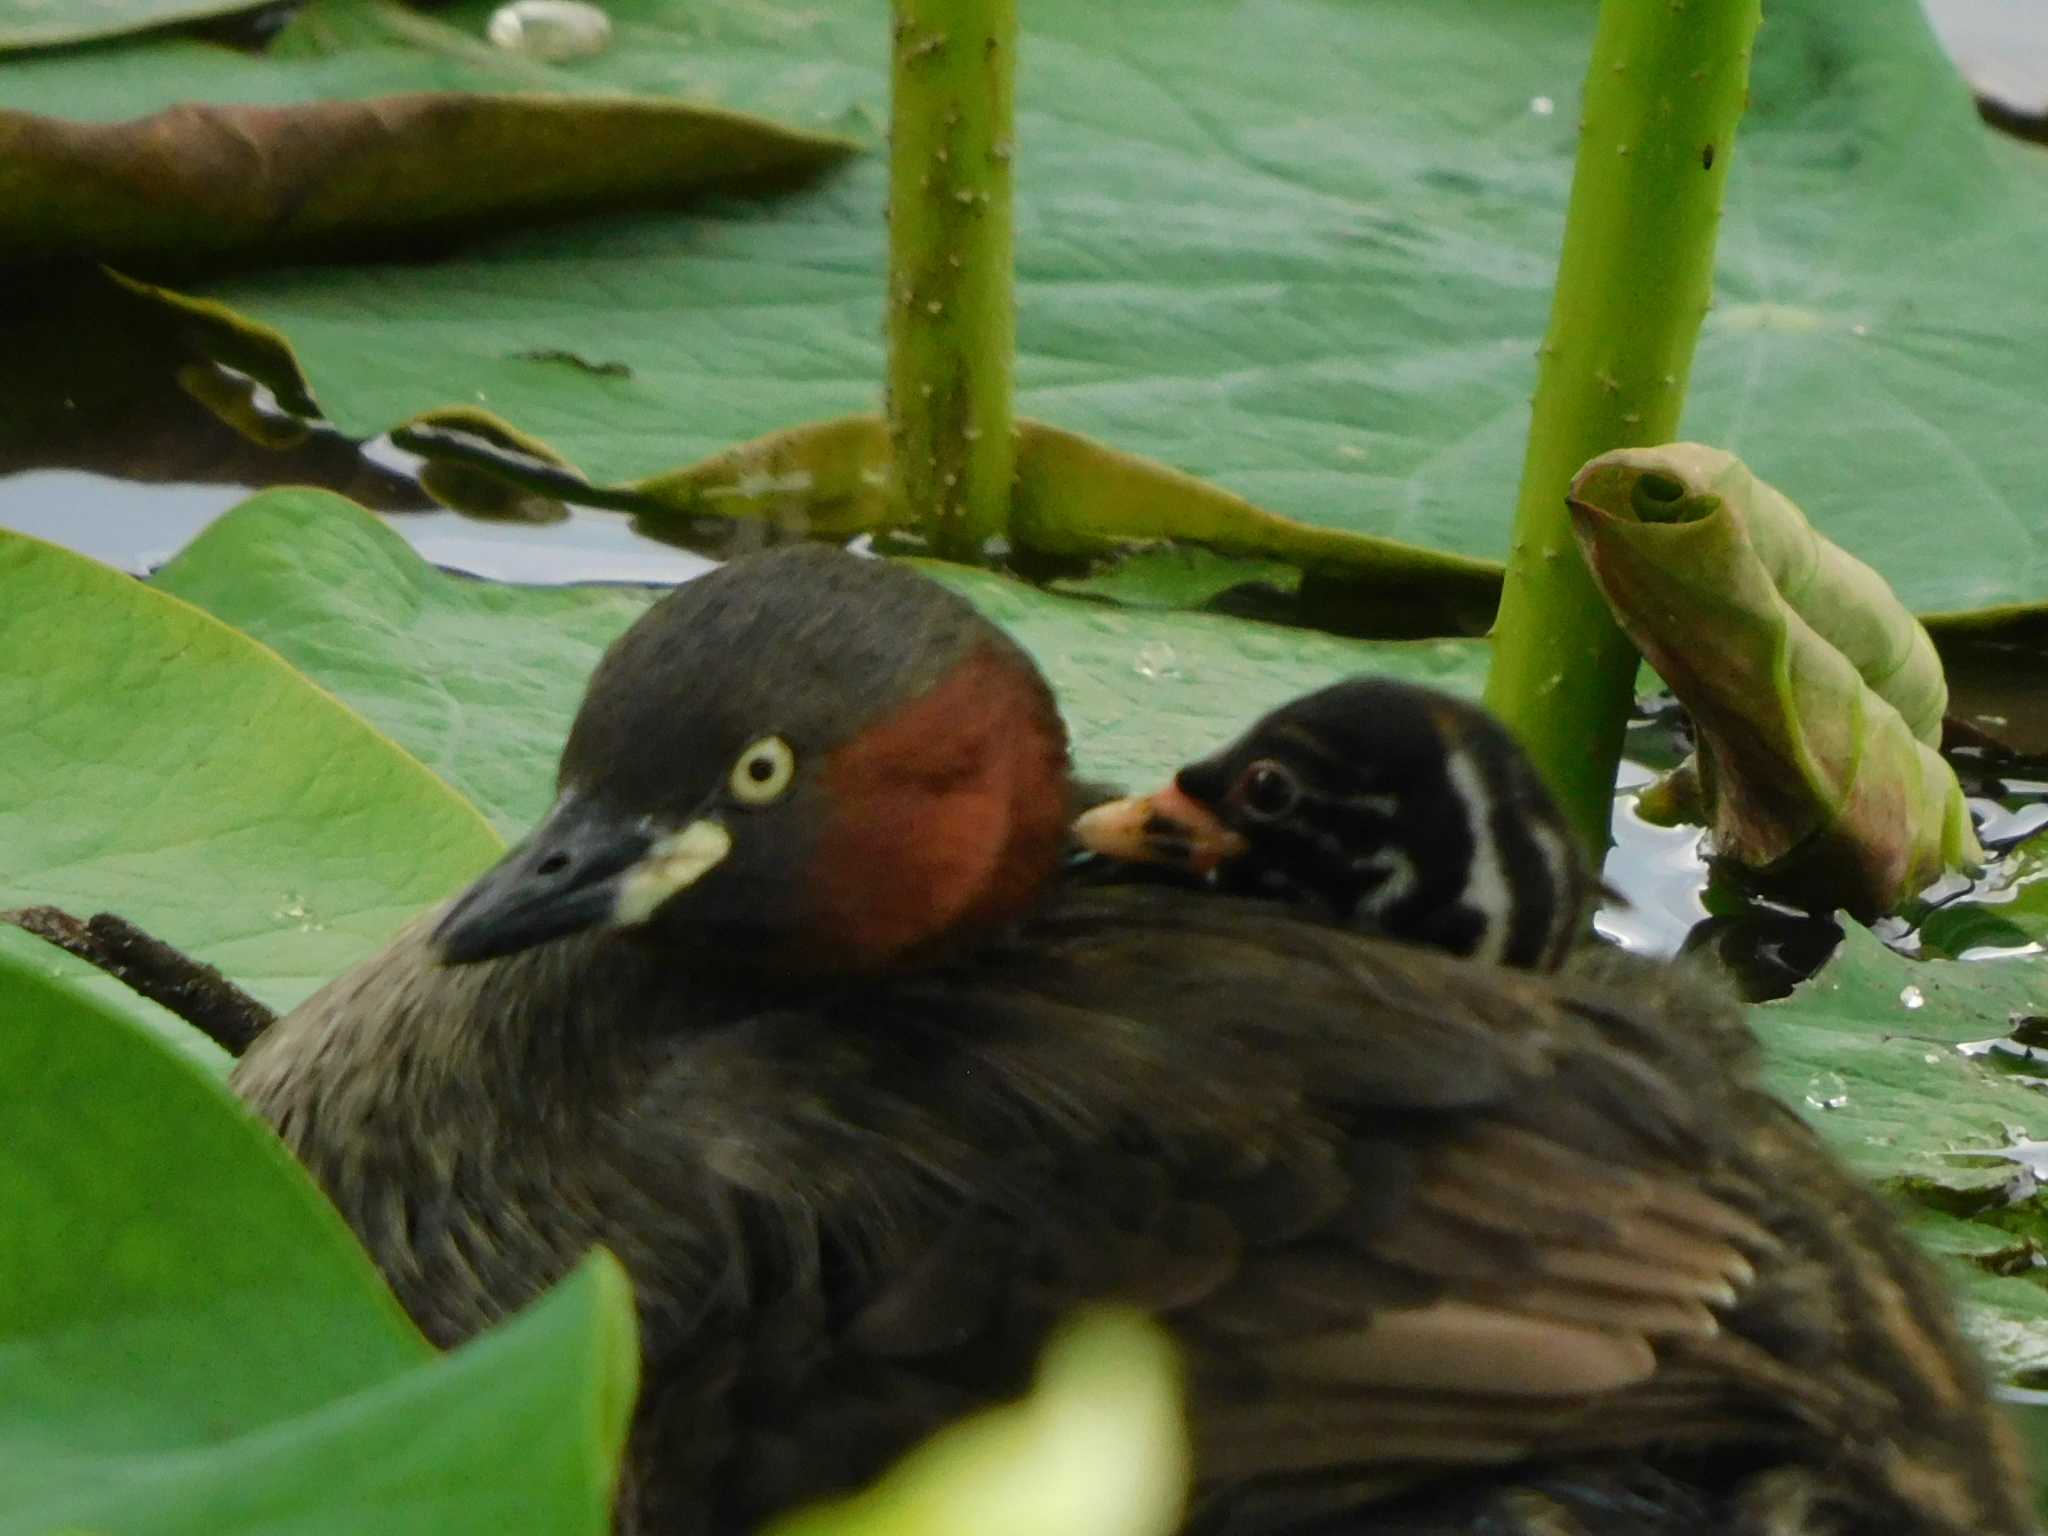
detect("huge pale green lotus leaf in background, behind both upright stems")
[19,0,2048,621]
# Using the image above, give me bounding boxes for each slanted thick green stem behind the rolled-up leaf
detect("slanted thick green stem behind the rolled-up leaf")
[1487,0,1759,852]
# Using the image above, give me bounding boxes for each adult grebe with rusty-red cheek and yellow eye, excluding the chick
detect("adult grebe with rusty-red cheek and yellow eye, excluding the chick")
[236,551,2032,1536]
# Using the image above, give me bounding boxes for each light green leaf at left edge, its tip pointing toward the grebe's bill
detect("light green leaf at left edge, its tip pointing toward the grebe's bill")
[0,512,502,1008]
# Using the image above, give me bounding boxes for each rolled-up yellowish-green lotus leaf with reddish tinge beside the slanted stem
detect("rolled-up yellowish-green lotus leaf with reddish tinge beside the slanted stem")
[1569,442,1982,918]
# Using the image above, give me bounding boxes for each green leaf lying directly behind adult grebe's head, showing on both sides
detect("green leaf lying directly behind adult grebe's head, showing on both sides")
[148,492,1487,811]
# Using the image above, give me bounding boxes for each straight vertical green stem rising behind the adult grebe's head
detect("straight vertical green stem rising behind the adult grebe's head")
[889,0,1018,559]
